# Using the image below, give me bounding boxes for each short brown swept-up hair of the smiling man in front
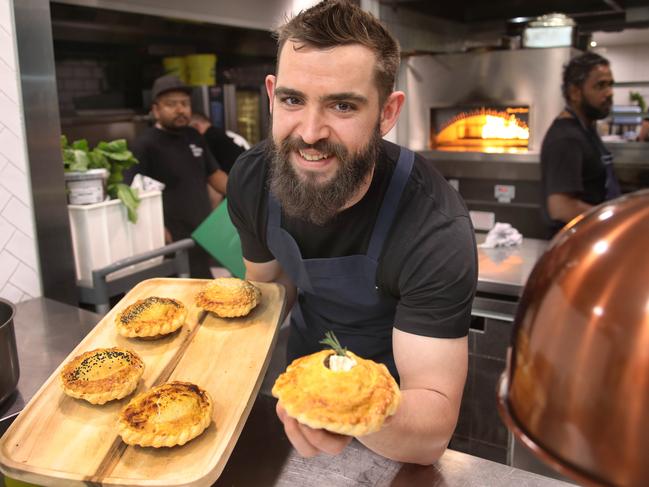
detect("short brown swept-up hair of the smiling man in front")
[275,0,400,105]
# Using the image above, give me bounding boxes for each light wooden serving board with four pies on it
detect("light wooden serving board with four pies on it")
[0,279,285,486]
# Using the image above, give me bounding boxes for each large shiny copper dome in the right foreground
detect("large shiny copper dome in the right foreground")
[498,190,649,487]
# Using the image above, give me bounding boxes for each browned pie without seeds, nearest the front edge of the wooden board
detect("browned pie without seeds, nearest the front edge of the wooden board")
[117,382,212,448]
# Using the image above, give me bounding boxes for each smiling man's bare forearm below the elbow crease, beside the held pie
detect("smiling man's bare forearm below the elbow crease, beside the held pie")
[358,389,458,465]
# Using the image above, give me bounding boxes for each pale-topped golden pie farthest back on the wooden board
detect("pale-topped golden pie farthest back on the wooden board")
[196,277,261,318]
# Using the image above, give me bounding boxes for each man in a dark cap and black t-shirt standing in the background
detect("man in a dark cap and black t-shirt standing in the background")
[129,75,228,279]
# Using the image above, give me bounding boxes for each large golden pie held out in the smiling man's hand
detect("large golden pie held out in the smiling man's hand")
[272,350,401,436]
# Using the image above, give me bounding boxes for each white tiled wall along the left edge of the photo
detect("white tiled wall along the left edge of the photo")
[0,0,42,303]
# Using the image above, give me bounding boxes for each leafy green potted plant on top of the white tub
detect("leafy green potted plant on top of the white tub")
[61,135,140,223]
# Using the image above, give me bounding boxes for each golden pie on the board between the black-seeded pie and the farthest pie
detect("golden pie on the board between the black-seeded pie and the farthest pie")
[115,296,187,338]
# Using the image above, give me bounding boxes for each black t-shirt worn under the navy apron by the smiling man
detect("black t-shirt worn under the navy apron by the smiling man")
[228,141,477,338]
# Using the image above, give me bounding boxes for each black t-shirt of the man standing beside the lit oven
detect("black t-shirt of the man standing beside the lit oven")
[541,118,606,232]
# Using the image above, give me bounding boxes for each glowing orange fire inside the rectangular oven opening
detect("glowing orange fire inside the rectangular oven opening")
[430,104,530,152]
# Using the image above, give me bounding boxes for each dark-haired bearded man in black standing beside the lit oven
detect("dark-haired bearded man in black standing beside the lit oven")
[541,52,620,237]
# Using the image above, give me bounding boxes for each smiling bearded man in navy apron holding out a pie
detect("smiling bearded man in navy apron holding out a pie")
[228,0,477,464]
